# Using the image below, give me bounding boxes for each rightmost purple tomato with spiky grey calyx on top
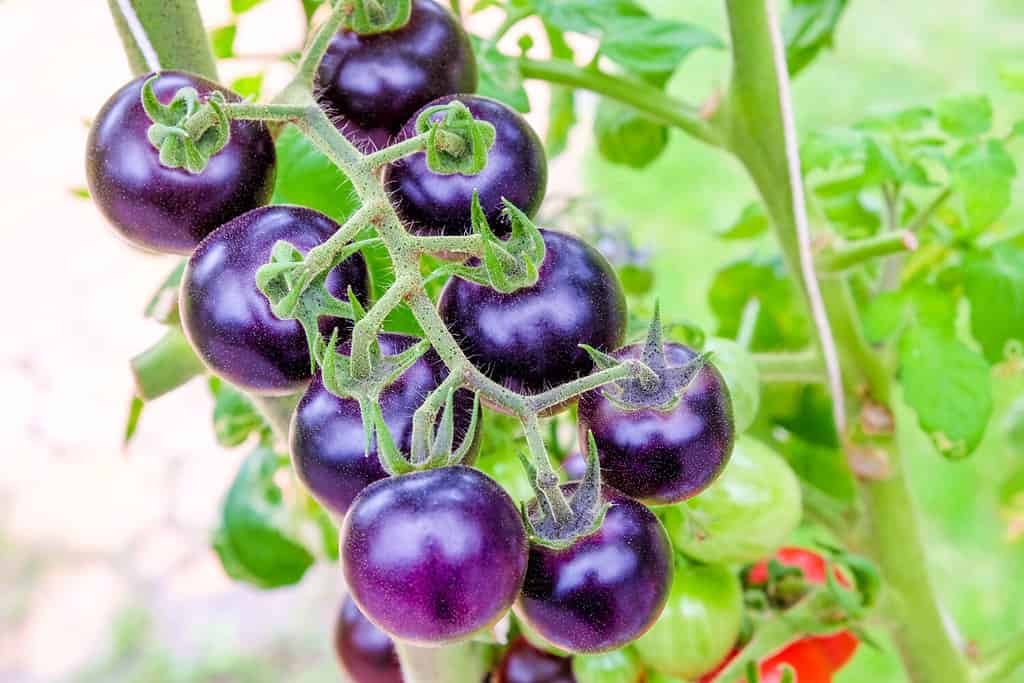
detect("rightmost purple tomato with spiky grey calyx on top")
[580,343,735,505]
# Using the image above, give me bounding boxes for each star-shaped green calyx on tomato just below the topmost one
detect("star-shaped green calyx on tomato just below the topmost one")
[416,99,497,175]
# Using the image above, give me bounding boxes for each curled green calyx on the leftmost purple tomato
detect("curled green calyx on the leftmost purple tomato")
[141,73,231,175]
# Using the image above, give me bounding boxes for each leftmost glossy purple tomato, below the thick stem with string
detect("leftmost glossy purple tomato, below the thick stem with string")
[86,71,276,254]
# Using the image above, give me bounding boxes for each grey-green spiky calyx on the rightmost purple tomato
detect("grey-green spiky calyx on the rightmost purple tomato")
[584,303,711,411]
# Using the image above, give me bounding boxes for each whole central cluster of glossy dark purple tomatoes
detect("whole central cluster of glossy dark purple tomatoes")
[81,0,733,673]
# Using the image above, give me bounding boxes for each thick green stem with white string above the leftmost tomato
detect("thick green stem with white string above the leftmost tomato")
[109,0,217,81]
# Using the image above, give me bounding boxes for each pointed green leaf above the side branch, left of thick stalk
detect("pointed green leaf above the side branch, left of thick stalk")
[601,16,724,74]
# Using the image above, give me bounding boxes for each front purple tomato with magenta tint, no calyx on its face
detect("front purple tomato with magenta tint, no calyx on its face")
[341,466,526,645]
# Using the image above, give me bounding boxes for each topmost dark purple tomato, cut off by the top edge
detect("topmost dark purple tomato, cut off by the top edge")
[316,0,476,150]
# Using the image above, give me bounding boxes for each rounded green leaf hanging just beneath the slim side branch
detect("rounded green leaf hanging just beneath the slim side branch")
[594,98,669,169]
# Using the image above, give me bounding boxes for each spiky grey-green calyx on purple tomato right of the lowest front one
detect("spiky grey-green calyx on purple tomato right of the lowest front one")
[519,434,611,550]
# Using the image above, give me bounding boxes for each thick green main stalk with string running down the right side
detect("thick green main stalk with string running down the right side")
[716,0,970,683]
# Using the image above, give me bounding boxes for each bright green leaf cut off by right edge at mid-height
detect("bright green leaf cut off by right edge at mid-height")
[963,244,1024,364]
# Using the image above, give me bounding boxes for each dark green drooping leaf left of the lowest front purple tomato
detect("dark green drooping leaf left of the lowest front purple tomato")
[213,446,313,589]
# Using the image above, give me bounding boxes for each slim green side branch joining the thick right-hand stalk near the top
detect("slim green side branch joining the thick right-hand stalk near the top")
[519,58,722,145]
